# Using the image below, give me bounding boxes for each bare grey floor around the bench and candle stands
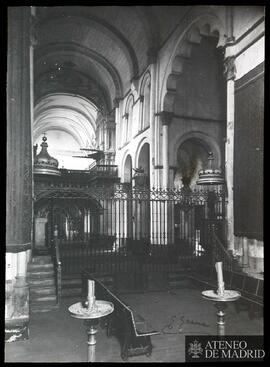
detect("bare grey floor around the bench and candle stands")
[5,289,263,363]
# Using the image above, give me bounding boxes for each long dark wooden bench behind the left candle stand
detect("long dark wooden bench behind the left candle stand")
[82,271,160,361]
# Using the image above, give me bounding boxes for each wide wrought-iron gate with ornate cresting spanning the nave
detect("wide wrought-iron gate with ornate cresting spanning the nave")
[33,184,225,275]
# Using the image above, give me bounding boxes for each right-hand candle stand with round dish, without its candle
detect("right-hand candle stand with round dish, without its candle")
[202,290,241,336]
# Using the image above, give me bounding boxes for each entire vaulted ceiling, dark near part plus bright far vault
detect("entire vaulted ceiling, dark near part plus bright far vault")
[32,6,189,165]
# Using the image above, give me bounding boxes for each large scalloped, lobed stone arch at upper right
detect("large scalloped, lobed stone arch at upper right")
[160,13,226,112]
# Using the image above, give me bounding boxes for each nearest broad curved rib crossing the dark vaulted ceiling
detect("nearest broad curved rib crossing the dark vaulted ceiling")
[36,16,135,89]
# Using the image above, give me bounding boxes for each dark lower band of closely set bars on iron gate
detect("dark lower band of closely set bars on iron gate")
[59,239,202,276]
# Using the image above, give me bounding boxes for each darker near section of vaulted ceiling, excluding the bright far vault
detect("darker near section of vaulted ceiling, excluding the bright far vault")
[34,6,189,113]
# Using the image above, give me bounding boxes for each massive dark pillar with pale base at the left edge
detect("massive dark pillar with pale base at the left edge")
[5,6,33,341]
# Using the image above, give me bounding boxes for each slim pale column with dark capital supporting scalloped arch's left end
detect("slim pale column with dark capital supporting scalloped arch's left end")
[160,111,173,188]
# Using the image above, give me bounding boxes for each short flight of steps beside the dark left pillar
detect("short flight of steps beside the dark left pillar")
[27,255,58,312]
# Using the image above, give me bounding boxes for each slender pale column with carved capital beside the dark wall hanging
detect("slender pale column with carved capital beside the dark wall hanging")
[224,56,236,250]
